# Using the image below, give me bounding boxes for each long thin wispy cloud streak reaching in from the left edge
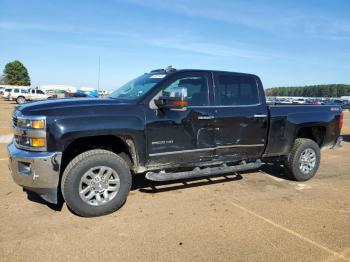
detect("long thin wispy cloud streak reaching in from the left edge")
[0,22,277,59]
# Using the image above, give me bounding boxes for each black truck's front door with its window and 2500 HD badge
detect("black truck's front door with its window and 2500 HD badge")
[146,72,215,166]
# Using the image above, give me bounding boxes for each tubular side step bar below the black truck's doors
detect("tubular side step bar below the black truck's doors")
[146,160,262,181]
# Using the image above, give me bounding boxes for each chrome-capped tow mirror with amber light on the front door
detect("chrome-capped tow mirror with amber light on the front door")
[154,87,188,109]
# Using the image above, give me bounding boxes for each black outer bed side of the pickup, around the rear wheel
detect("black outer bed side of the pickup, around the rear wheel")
[264,105,342,157]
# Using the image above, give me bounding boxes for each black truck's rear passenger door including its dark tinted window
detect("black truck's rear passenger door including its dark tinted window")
[214,72,268,161]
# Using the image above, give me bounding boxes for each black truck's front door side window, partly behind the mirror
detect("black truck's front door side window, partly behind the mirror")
[163,76,209,106]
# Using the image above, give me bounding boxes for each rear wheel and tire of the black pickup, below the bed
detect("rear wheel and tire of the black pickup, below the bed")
[286,138,321,181]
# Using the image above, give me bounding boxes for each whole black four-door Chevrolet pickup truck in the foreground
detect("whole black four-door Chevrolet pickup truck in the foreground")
[8,68,342,216]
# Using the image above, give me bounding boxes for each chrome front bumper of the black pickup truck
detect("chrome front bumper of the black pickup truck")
[7,143,62,204]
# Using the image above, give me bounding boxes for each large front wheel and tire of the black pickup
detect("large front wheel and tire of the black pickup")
[61,149,132,217]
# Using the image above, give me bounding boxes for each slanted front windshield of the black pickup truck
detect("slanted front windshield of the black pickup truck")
[109,74,166,100]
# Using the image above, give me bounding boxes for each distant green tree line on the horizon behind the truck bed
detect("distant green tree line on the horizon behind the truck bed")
[265,84,350,97]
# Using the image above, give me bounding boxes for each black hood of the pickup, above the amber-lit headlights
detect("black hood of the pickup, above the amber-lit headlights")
[16,98,135,116]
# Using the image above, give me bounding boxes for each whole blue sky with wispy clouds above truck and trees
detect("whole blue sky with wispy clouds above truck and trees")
[0,0,350,90]
